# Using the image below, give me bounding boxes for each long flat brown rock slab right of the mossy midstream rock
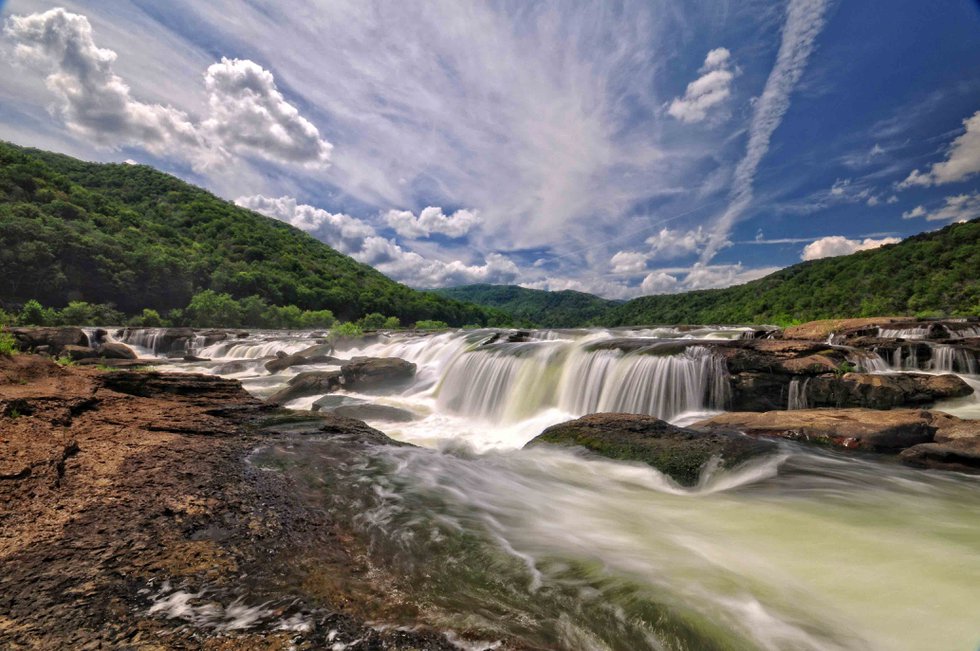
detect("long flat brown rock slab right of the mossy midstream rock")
[691,409,944,452]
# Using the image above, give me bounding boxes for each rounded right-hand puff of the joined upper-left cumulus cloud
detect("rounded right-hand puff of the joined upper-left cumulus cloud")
[201,58,333,168]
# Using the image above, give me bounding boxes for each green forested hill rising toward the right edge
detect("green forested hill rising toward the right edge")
[606,219,980,325]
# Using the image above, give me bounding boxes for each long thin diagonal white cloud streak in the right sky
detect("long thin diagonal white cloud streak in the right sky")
[701,0,828,263]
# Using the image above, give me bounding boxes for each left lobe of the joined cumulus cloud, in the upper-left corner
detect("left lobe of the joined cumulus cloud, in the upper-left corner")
[4,8,201,153]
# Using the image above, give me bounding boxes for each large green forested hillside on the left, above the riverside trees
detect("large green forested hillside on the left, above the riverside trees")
[0,142,510,325]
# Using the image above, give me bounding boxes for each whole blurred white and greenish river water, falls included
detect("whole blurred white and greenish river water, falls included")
[117,328,980,651]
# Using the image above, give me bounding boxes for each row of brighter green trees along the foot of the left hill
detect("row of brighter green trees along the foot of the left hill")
[0,290,456,336]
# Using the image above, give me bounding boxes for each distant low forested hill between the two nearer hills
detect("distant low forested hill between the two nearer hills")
[433,285,617,328]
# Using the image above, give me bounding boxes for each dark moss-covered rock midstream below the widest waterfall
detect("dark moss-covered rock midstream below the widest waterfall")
[525,413,775,486]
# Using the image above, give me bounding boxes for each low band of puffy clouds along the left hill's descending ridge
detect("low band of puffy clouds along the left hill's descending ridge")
[235,195,520,287]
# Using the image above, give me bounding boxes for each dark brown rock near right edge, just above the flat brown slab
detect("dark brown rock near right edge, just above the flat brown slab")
[806,373,973,409]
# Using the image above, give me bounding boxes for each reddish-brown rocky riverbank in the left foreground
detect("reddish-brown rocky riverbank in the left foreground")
[0,356,502,649]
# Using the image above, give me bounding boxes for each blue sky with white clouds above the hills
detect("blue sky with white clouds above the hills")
[0,0,980,299]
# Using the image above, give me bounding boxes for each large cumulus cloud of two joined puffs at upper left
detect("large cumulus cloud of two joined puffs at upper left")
[4,8,332,168]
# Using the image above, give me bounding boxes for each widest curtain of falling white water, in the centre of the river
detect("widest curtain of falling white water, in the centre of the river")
[438,342,728,422]
